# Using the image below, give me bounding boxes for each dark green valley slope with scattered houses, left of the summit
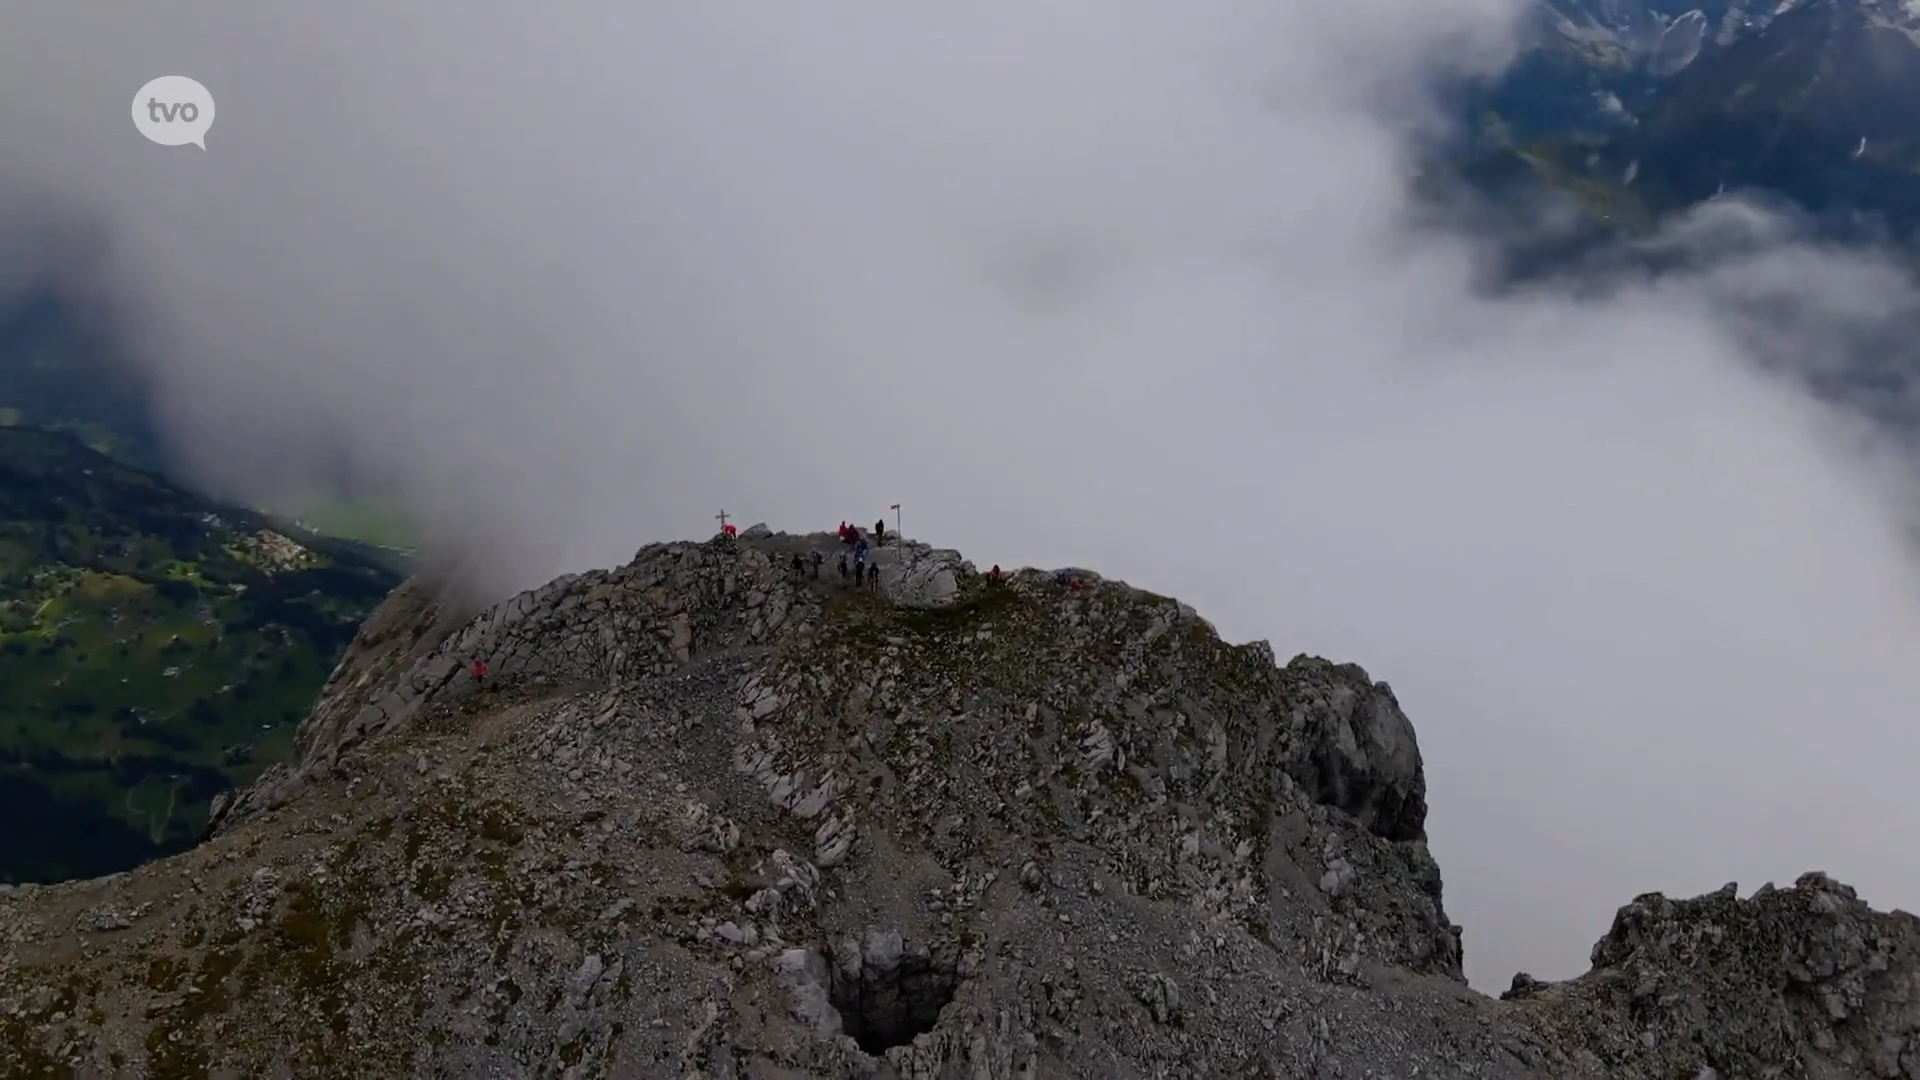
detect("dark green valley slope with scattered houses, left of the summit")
[0,427,401,882]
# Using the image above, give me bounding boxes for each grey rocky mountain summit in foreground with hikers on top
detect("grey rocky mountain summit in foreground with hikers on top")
[0,528,1920,1080]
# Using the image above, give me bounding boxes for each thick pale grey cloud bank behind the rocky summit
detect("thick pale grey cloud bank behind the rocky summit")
[11,0,1920,988]
